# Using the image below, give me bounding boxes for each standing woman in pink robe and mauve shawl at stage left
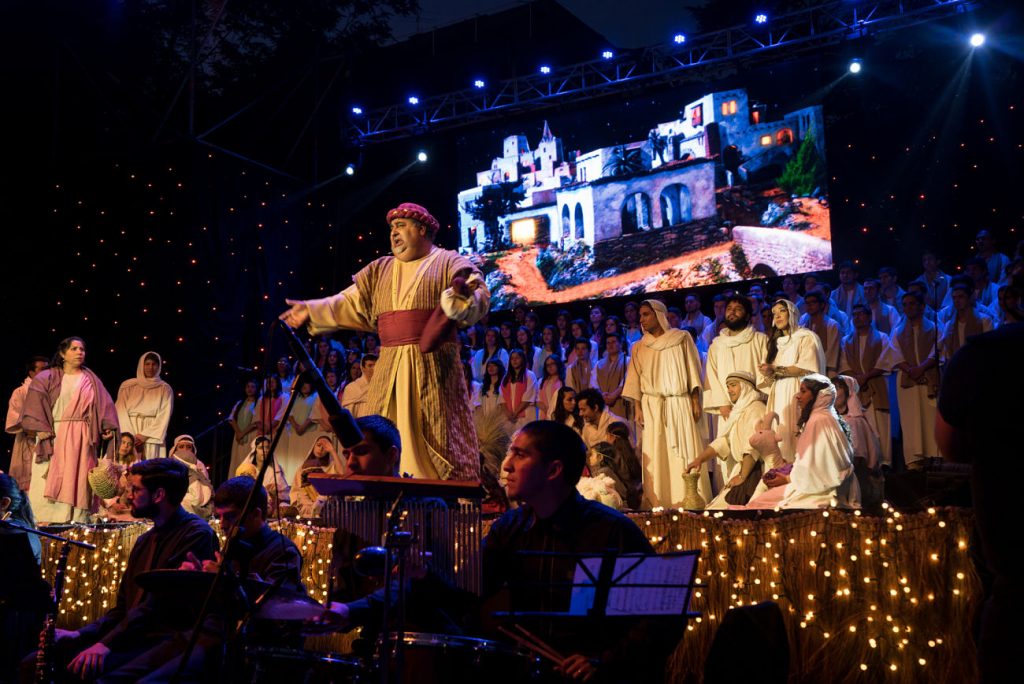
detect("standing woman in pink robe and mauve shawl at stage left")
[20,337,119,522]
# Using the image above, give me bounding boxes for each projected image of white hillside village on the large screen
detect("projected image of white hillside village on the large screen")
[459,89,833,308]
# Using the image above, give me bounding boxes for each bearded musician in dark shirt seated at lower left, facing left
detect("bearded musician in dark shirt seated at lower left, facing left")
[22,459,217,681]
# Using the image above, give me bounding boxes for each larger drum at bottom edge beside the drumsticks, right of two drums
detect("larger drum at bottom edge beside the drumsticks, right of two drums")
[377,632,539,684]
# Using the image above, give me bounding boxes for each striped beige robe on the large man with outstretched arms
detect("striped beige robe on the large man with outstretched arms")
[305,248,489,479]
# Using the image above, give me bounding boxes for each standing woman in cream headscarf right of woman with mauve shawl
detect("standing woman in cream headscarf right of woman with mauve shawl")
[114,351,174,459]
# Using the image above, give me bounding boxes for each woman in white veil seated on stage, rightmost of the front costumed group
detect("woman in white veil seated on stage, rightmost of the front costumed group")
[748,373,860,509]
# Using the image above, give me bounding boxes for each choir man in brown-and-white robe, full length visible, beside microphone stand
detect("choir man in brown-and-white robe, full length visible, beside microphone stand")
[889,292,939,469]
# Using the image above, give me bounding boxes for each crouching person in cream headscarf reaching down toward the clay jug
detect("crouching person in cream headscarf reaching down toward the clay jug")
[686,371,765,509]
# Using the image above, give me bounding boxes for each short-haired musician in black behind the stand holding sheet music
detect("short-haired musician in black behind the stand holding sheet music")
[324,421,683,682]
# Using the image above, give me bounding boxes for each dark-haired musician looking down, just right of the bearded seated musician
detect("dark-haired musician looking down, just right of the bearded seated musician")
[102,476,306,684]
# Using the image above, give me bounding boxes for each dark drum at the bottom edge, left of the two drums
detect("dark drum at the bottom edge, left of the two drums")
[246,647,366,684]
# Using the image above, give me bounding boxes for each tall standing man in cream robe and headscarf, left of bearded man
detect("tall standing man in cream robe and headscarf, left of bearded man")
[623,299,711,507]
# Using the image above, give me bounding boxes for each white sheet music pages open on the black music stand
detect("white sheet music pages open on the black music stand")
[569,554,697,615]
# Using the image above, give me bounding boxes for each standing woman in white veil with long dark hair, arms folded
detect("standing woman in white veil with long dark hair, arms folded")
[760,299,825,463]
